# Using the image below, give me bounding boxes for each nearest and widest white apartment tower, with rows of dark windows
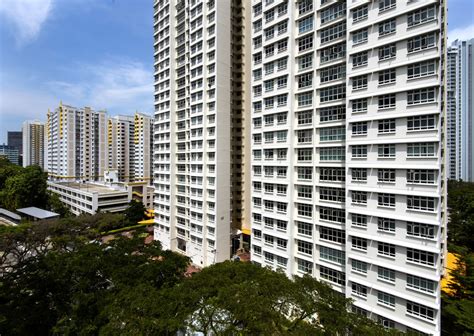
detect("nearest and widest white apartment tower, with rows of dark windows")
[250,0,446,335]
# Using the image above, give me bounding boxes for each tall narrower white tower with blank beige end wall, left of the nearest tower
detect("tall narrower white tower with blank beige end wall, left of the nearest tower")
[153,0,250,266]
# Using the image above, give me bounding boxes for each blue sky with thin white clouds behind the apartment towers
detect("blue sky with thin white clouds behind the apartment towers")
[0,0,474,144]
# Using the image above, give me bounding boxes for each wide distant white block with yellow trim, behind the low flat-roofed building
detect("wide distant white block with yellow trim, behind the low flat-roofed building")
[45,103,108,181]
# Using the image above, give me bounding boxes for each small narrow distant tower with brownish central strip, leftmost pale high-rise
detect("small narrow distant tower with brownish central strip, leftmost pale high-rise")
[20,120,45,168]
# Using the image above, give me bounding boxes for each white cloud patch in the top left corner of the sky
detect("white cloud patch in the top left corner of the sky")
[0,0,53,45]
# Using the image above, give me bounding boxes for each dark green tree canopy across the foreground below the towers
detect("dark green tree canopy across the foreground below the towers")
[0,220,400,336]
